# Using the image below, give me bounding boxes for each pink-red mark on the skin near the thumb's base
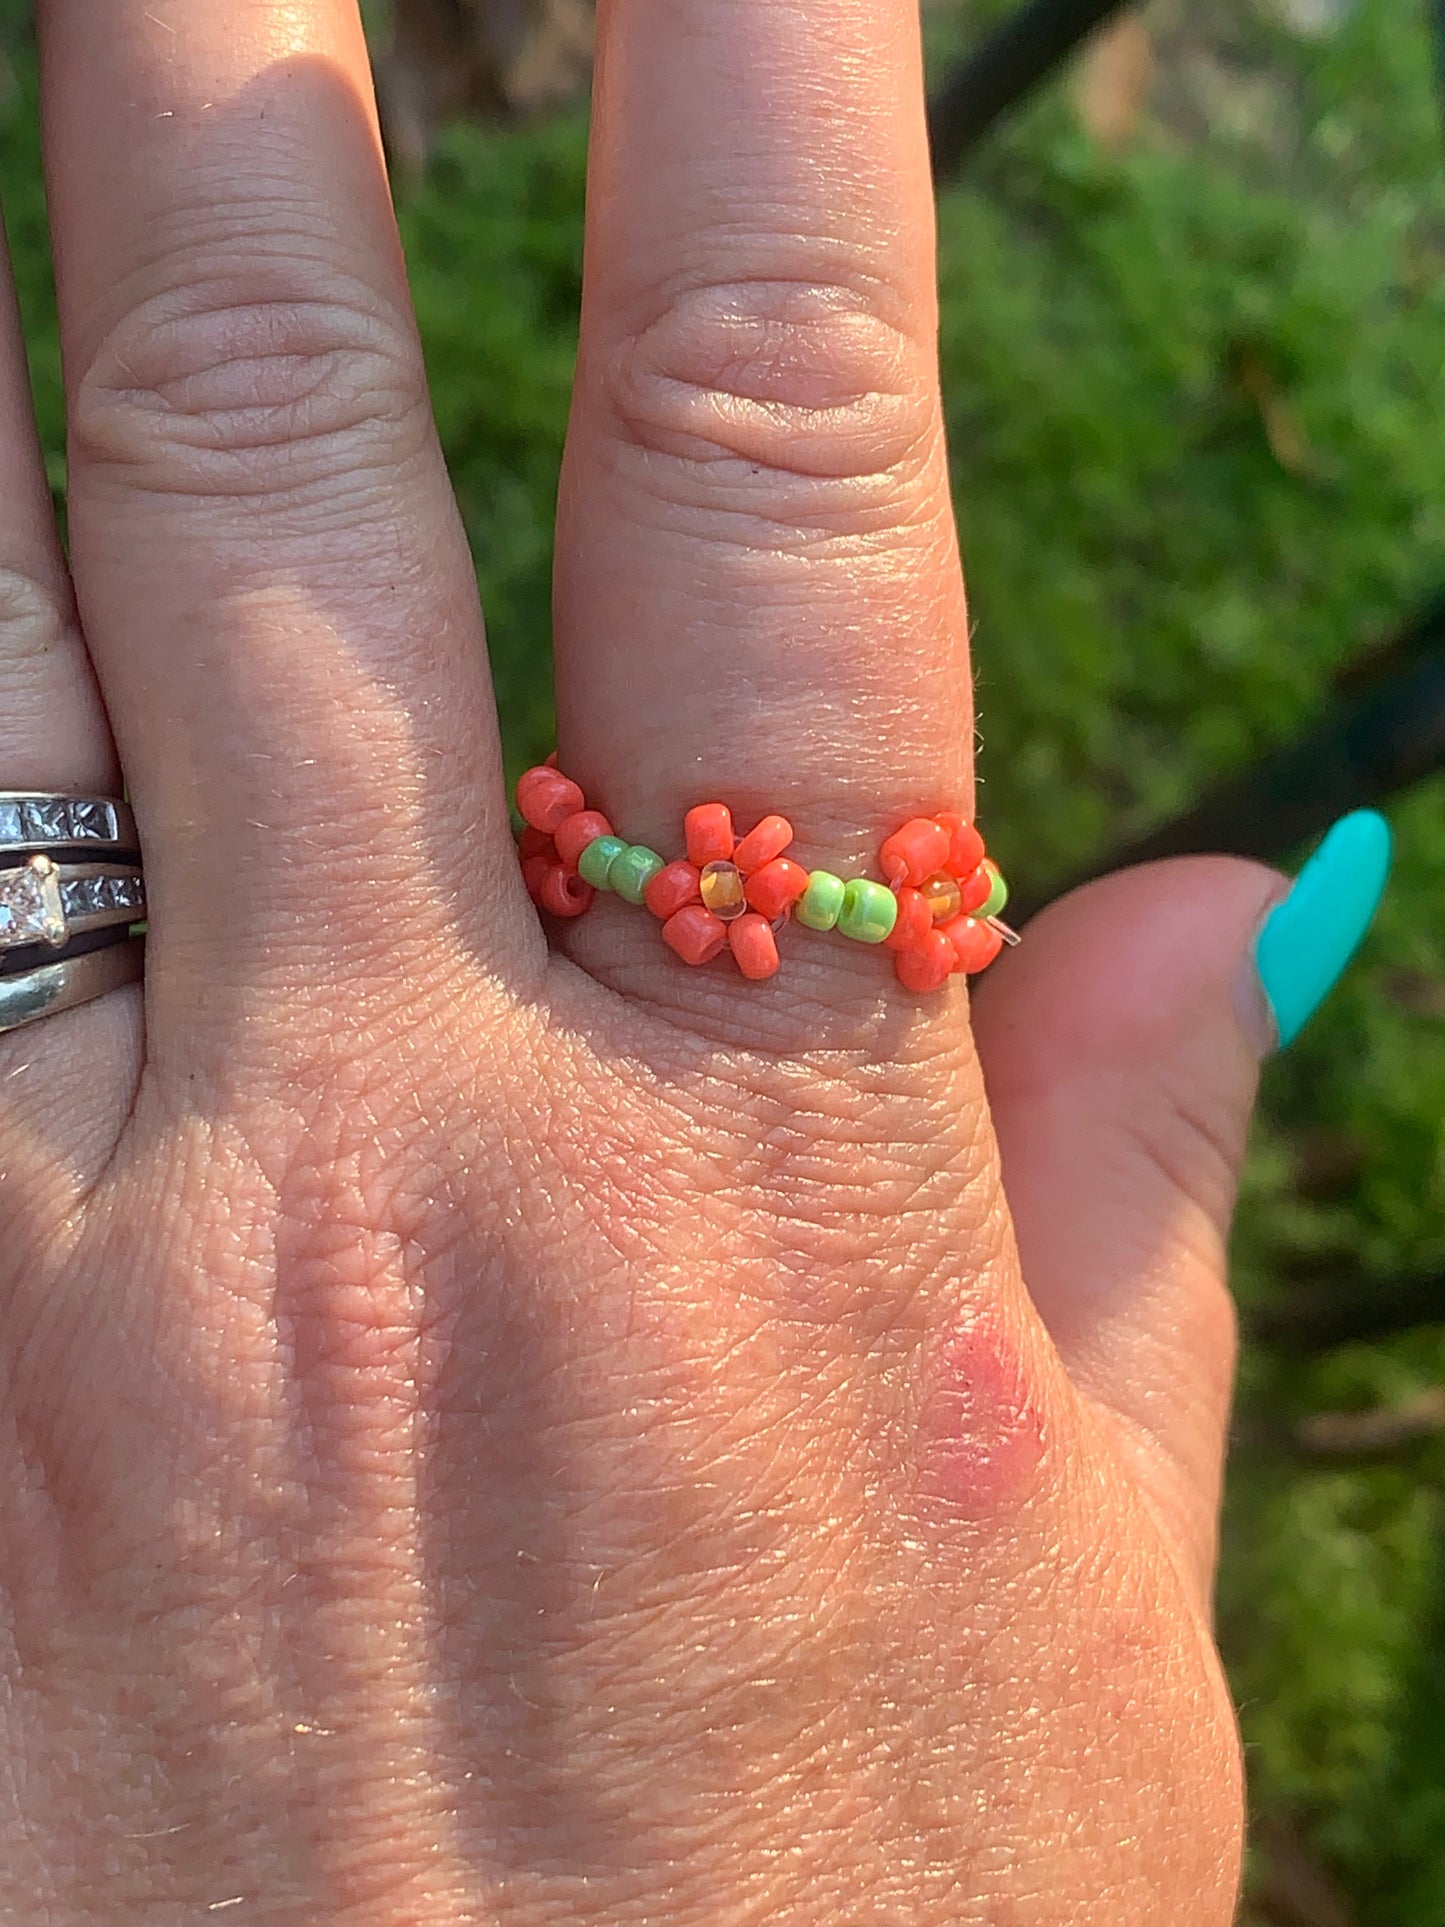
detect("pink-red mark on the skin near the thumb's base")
[919,1310,1046,1520]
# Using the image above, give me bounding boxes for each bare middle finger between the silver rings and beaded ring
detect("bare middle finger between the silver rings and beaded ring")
[39,0,524,1043]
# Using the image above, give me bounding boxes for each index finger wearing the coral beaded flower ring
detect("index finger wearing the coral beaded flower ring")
[557,0,971,1025]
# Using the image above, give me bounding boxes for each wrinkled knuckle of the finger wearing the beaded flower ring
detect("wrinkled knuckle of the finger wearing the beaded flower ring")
[603,279,940,518]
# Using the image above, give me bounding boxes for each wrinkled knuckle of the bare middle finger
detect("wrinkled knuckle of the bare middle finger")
[71,264,430,495]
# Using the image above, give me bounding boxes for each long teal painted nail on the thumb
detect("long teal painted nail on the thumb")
[1254,809,1389,1050]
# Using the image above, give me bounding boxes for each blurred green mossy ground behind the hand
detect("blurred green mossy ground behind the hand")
[0,0,1445,1927]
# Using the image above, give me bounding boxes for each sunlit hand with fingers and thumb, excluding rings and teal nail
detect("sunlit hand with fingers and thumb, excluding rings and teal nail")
[0,0,1279,1927]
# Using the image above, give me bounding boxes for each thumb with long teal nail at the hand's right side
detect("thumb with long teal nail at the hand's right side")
[973,811,1389,1592]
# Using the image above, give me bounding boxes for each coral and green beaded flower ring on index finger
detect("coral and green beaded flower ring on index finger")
[516,763,1019,990]
